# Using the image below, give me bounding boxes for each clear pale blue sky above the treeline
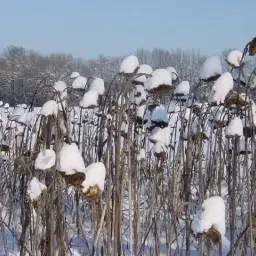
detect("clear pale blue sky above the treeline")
[0,0,256,58]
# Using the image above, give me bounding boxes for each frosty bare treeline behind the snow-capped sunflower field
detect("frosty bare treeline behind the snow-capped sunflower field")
[0,46,248,105]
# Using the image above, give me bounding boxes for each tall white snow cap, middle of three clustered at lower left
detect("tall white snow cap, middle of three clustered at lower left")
[57,143,85,175]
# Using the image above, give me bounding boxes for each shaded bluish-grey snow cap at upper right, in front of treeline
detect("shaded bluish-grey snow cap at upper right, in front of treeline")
[199,56,223,80]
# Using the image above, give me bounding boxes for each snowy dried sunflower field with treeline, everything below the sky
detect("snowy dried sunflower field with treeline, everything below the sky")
[0,38,256,256]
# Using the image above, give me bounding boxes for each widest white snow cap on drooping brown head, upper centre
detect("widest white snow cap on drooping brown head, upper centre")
[145,68,172,91]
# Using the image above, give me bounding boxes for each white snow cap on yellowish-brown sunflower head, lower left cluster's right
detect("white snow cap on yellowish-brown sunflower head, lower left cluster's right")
[81,162,106,193]
